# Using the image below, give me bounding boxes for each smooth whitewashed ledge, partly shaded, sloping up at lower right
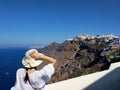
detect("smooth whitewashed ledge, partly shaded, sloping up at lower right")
[45,62,120,90]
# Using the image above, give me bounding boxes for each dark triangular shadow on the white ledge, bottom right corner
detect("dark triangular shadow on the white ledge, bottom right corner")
[84,67,120,90]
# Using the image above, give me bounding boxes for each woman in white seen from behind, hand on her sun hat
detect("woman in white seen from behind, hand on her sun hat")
[11,49,56,90]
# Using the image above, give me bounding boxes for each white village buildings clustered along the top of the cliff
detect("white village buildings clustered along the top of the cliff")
[67,34,120,49]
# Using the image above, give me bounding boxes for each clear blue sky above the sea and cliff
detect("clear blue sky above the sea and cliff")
[0,0,120,47]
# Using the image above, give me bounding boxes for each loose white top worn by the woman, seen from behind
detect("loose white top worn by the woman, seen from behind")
[11,64,54,90]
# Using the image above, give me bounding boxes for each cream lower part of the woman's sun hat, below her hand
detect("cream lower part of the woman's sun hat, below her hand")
[22,57,43,68]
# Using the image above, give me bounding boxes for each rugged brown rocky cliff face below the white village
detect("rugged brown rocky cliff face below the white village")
[39,34,120,83]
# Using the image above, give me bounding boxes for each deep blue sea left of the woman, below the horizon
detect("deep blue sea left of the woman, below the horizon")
[0,48,28,90]
